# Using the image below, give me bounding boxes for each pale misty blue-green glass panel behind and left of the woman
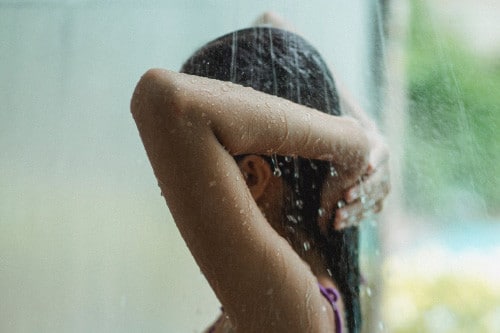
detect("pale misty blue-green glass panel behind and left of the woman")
[0,0,371,332]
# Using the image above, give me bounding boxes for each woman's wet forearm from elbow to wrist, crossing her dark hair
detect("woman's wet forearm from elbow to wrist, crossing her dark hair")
[132,70,368,180]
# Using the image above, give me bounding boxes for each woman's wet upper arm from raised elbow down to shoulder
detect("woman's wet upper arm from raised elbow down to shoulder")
[131,68,360,331]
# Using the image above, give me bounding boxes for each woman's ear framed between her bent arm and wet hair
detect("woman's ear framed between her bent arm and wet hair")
[238,155,273,201]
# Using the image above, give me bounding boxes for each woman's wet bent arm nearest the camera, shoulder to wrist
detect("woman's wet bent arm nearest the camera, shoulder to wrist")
[131,70,368,332]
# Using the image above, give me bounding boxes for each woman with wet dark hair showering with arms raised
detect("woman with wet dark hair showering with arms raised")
[131,27,385,332]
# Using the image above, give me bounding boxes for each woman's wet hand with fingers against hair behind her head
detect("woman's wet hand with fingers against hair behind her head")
[333,131,390,230]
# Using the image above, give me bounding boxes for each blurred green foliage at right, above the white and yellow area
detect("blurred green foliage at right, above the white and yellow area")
[404,0,500,215]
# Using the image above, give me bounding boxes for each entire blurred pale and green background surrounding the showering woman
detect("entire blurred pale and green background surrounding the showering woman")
[0,0,500,332]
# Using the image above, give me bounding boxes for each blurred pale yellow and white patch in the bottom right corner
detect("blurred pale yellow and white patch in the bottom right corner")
[383,245,500,333]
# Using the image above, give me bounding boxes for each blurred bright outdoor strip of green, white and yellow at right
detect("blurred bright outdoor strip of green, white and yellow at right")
[381,0,500,332]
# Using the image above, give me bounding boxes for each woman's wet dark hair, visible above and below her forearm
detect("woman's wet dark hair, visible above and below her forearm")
[181,27,361,332]
